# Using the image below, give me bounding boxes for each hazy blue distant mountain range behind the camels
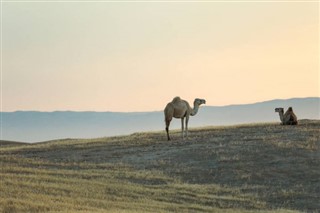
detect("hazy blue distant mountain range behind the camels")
[1,97,320,142]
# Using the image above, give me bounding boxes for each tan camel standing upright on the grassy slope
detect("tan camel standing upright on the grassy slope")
[164,97,206,141]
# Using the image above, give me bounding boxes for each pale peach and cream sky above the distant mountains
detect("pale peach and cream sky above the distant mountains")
[1,0,320,112]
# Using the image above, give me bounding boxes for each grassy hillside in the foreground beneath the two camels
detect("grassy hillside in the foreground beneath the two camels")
[0,120,320,212]
